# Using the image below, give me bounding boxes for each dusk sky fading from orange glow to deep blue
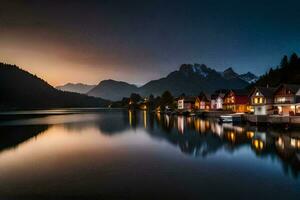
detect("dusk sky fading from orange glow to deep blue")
[0,0,300,86]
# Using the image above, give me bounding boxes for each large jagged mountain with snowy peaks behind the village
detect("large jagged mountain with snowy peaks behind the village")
[139,64,249,96]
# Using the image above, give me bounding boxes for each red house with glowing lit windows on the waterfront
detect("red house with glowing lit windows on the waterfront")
[223,90,251,113]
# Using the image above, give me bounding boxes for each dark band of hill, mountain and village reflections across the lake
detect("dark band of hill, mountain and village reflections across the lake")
[0,111,300,176]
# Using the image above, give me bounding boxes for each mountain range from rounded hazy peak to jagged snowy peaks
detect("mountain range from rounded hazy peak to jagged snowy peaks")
[87,64,253,101]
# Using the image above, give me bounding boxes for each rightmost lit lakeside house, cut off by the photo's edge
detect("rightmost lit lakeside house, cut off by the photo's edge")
[274,84,300,115]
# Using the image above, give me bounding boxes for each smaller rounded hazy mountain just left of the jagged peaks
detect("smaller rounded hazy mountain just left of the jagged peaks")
[87,80,138,101]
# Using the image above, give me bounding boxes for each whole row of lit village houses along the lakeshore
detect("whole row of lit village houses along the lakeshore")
[129,84,300,125]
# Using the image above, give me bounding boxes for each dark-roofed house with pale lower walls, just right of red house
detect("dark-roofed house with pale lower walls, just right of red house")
[249,87,276,115]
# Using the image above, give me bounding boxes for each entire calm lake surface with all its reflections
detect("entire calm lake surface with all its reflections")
[0,110,300,199]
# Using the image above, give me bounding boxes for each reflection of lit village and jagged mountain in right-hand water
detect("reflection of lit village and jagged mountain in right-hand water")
[135,111,300,177]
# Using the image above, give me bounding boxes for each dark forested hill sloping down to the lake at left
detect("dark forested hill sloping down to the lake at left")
[0,63,109,109]
